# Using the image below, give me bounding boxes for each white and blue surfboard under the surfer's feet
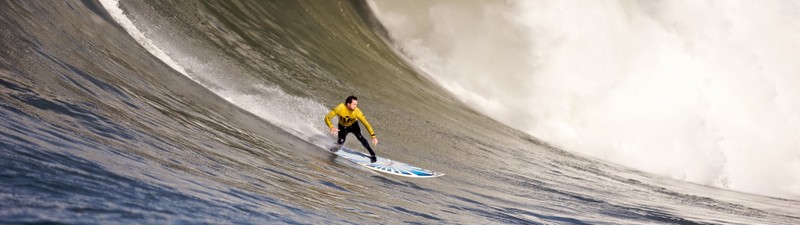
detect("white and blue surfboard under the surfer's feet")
[334,147,444,178]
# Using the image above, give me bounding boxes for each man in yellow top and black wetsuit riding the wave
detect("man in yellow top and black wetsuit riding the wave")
[325,95,378,163]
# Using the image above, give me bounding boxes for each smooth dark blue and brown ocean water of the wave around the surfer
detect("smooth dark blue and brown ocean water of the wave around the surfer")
[0,0,800,224]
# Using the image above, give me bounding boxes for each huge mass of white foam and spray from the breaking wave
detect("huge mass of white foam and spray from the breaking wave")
[370,0,800,198]
